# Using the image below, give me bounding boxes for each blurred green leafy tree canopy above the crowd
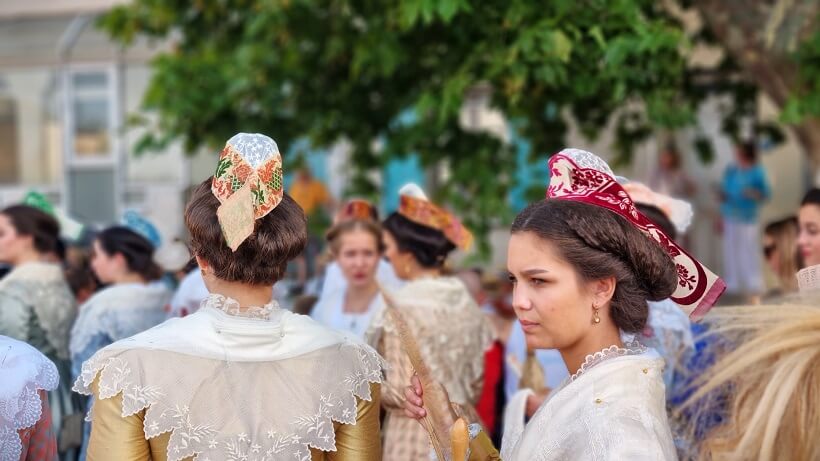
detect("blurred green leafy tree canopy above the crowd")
[101,0,816,249]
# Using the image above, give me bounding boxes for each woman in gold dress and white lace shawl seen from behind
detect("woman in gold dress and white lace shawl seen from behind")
[75,133,383,461]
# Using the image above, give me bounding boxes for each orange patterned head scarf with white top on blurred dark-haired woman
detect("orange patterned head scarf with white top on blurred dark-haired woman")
[398,184,473,250]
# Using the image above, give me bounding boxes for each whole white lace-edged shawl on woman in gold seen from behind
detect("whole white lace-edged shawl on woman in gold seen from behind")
[74,295,383,461]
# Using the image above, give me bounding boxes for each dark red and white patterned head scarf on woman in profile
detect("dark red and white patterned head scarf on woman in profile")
[547,149,726,320]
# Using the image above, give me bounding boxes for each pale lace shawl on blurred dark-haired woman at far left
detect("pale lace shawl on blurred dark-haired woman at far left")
[0,262,77,358]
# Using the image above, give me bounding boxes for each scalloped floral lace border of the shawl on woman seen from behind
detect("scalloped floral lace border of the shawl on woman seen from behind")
[74,343,385,461]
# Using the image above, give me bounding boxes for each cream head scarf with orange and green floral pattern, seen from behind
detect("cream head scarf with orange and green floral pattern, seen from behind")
[211,133,284,251]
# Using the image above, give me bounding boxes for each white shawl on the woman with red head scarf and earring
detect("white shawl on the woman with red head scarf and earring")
[501,348,677,461]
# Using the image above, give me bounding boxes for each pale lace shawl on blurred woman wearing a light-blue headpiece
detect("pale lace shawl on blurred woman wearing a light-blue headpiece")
[69,282,172,358]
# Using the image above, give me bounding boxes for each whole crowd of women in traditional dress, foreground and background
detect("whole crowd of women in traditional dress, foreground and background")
[0,133,820,461]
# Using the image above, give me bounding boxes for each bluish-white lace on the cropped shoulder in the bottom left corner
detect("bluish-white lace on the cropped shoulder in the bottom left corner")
[0,347,60,460]
